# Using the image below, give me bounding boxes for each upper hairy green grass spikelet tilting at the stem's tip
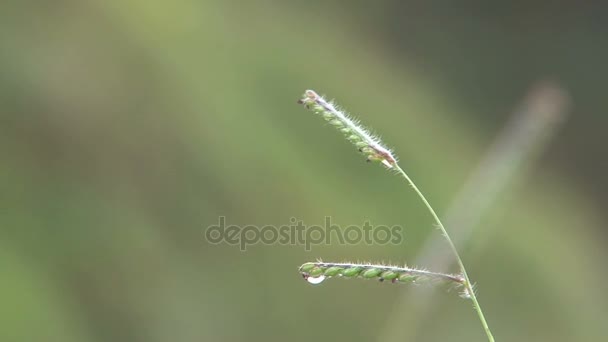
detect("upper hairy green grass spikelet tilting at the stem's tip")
[298,90,397,169]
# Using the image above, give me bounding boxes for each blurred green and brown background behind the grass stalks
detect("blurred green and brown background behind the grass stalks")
[0,0,608,342]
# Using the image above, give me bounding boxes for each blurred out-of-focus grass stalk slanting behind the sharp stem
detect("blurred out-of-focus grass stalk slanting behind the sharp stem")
[377,81,570,342]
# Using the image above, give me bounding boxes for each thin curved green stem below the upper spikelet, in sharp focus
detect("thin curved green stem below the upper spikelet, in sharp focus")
[393,164,494,342]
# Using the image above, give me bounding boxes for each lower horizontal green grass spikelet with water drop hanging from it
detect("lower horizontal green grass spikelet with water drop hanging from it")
[299,261,465,287]
